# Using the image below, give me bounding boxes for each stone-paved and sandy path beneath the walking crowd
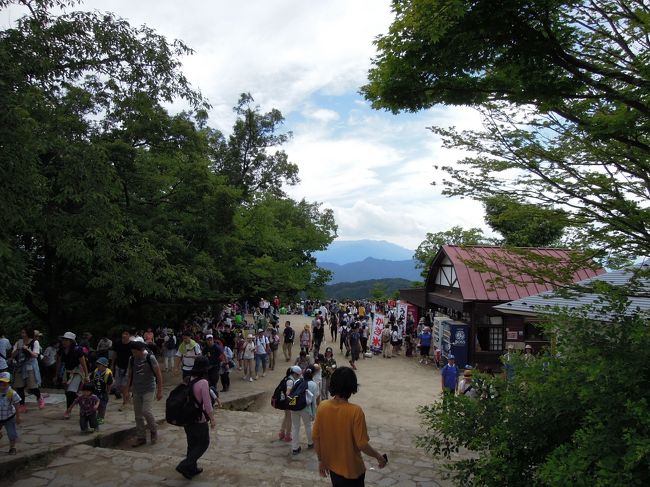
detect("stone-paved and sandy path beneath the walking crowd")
[0,316,458,487]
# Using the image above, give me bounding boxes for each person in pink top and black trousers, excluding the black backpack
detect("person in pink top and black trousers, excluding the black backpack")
[176,357,216,480]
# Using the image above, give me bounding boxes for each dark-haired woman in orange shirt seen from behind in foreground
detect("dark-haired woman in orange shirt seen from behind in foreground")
[312,367,387,487]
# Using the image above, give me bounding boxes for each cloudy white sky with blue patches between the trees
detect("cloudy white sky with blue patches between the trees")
[0,0,485,249]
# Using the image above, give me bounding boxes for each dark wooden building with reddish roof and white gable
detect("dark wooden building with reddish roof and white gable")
[400,245,605,367]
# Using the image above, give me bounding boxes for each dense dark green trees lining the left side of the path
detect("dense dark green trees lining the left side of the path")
[0,0,336,335]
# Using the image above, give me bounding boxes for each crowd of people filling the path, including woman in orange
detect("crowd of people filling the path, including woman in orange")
[0,297,430,485]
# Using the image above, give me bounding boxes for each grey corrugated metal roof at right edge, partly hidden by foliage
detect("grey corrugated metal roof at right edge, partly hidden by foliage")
[494,269,650,321]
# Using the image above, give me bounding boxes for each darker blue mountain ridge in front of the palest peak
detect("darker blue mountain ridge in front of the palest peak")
[318,257,422,284]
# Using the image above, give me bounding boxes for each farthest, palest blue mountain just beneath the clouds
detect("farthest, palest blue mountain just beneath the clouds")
[314,240,414,264]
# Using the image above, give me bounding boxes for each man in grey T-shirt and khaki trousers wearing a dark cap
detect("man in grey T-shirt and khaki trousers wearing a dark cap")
[128,340,163,447]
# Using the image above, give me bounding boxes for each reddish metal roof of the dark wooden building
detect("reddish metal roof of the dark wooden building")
[436,245,606,301]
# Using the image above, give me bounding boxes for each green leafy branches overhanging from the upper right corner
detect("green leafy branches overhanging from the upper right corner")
[363,0,650,264]
